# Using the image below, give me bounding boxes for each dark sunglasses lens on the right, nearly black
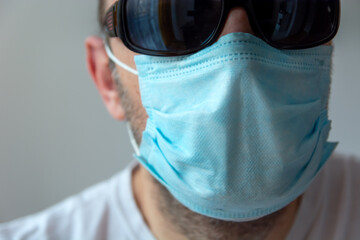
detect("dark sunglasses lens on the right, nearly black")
[253,0,339,48]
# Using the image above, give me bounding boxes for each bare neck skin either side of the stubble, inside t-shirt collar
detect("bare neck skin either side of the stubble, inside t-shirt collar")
[132,165,300,240]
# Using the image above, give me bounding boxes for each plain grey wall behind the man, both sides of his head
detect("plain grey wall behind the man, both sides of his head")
[0,0,360,222]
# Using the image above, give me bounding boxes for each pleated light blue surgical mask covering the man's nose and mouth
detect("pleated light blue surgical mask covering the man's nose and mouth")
[105,33,336,221]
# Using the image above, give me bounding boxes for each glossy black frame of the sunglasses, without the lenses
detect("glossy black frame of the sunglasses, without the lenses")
[104,0,341,56]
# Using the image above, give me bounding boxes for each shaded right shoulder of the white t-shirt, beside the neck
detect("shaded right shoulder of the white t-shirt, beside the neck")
[288,154,360,240]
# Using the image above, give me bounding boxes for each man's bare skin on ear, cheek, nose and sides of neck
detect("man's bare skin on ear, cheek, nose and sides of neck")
[85,0,331,240]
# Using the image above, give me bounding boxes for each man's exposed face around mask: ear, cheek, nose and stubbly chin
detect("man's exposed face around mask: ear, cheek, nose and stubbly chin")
[86,0,330,239]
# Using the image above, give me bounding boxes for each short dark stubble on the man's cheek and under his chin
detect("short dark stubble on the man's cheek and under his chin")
[110,65,285,240]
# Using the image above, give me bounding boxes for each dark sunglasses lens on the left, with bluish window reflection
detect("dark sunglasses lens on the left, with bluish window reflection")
[125,0,222,54]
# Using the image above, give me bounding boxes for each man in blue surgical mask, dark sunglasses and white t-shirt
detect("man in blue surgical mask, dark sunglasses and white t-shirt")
[0,0,360,239]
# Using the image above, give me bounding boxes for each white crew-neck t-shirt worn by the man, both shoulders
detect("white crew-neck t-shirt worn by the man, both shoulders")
[0,155,360,240]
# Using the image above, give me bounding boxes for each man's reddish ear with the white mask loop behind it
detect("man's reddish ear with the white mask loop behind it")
[85,36,125,120]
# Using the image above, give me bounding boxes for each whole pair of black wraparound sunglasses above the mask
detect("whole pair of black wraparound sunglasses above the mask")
[104,0,340,56]
